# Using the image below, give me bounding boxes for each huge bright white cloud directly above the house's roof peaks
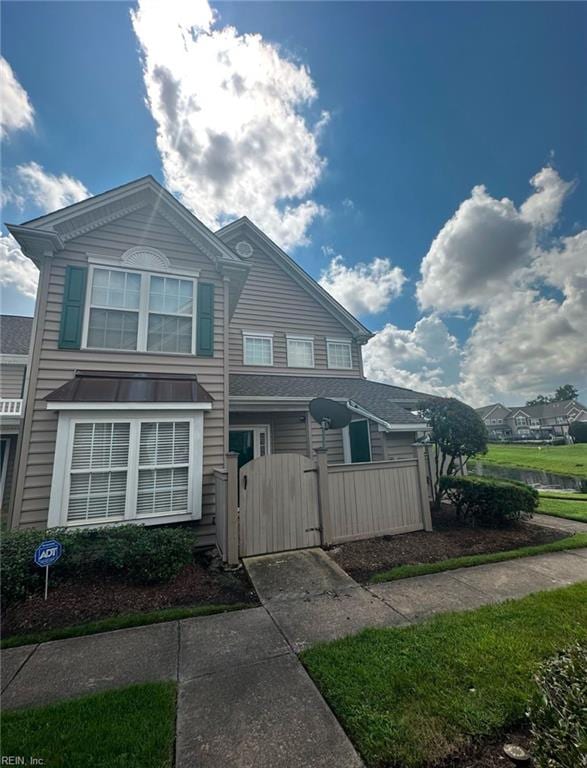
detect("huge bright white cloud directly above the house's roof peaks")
[131,0,328,248]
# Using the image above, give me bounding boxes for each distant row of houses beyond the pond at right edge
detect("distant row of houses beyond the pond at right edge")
[477,400,587,440]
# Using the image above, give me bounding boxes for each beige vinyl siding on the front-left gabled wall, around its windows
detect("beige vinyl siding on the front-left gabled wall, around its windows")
[16,209,225,544]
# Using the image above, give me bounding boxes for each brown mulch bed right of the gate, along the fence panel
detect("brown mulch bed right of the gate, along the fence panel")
[328,507,569,582]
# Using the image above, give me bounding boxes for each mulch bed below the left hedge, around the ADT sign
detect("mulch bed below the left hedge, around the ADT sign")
[2,553,258,637]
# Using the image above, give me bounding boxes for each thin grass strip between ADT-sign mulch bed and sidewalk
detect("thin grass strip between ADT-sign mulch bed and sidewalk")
[0,603,250,648]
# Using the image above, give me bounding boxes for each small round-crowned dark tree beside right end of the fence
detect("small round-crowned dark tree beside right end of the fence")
[419,397,488,509]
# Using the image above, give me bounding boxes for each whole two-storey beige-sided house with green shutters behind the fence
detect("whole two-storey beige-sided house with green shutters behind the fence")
[9,177,432,544]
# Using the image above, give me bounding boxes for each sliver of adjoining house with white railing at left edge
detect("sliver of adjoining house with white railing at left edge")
[0,315,33,521]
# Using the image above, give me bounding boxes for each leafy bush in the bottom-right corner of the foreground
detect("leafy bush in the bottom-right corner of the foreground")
[529,645,587,768]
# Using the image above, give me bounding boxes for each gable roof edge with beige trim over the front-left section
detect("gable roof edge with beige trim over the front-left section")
[6,176,248,314]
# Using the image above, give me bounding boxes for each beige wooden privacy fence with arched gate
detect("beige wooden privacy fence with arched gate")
[215,446,432,564]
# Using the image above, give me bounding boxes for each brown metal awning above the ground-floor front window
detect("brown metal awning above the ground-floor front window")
[45,371,213,403]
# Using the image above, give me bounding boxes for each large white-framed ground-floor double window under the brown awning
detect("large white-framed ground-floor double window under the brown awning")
[49,412,202,525]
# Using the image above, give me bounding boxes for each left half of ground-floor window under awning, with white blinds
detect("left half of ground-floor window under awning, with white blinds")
[67,423,130,523]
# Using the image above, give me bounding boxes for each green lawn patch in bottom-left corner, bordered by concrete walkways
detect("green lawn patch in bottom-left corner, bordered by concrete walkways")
[2,683,176,768]
